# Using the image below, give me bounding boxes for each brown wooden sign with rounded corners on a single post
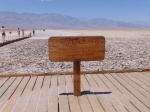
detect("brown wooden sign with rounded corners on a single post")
[49,36,105,96]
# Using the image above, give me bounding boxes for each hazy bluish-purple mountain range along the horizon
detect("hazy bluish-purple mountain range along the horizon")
[0,12,150,29]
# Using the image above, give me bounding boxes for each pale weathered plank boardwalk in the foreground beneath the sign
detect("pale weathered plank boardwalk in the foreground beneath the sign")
[0,72,150,112]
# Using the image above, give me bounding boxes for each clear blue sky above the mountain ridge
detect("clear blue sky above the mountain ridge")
[0,0,150,22]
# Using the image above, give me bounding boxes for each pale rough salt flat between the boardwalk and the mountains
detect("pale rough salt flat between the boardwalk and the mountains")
[0,29,150,74]
